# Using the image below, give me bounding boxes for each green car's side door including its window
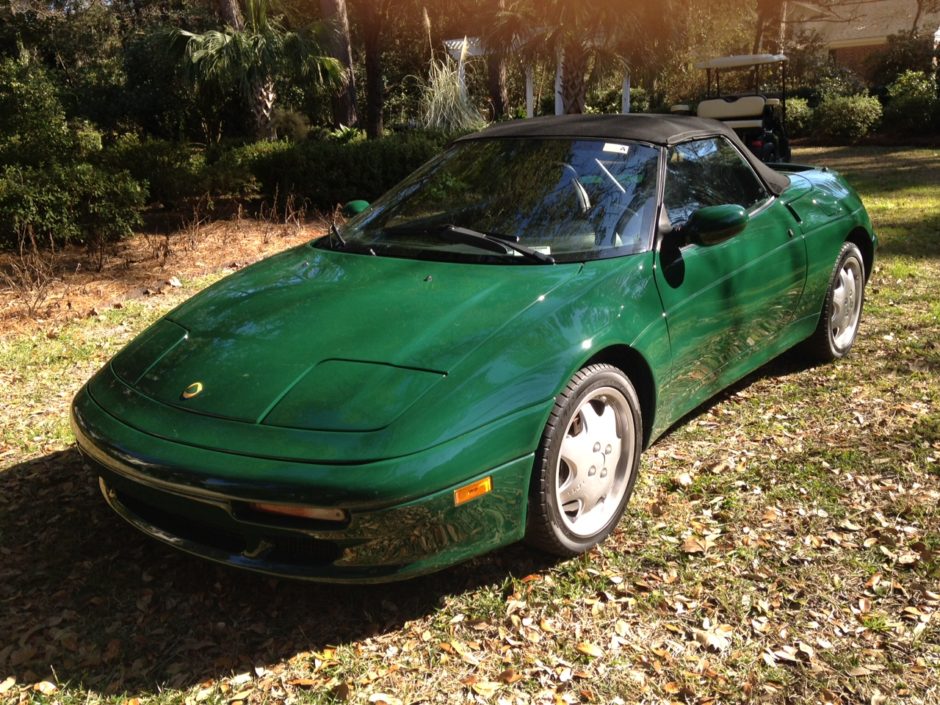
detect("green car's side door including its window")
[655,137,806,414]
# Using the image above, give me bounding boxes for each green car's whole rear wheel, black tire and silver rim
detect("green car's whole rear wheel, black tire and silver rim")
[802,242,866,362]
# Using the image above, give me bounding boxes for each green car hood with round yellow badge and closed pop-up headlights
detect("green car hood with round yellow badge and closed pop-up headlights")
[112,245,579,431]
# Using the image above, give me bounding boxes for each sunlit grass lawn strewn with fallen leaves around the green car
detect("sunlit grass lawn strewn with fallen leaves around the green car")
[0,148,940,705]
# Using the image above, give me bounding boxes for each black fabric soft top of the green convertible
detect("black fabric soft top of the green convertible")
[457,113,790,194]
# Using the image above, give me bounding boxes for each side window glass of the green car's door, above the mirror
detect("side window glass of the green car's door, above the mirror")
[663,137,768,225]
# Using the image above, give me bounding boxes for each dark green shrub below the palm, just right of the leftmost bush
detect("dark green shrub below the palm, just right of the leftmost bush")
[102,134,210,207]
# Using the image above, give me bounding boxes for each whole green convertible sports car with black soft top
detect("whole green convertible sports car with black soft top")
[72,115,876,581]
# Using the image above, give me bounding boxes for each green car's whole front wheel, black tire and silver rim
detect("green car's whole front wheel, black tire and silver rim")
[526,365,643,557]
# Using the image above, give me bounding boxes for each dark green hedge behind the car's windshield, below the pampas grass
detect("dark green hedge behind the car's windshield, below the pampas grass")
[246,132,449,210]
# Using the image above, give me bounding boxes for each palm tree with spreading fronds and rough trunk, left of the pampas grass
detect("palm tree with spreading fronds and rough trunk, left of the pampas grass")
[171,0,343,139]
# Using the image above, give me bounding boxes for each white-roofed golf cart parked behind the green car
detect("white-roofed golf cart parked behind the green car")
[672,54,790,162]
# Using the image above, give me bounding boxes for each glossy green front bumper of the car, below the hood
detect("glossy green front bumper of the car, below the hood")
[71,389,533,582]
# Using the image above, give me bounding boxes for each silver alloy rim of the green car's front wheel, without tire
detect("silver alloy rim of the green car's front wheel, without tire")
[555,387,636,538]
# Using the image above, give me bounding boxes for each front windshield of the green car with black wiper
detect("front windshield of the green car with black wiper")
[318,139,659,264]
